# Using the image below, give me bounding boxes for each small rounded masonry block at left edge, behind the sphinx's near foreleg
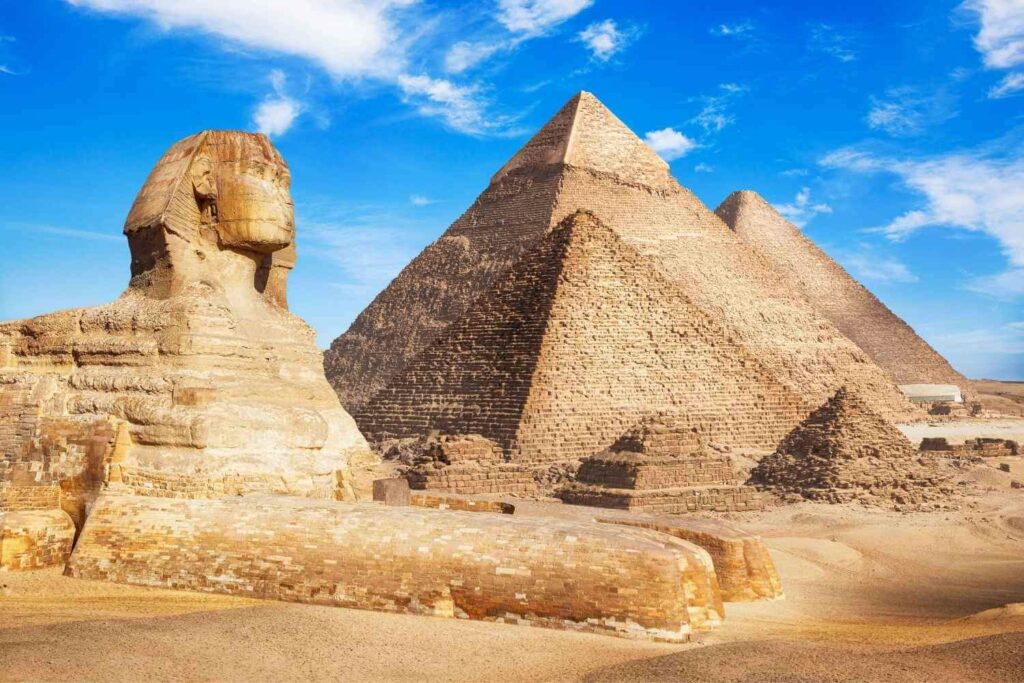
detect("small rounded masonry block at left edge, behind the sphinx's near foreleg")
[0,508,75,570]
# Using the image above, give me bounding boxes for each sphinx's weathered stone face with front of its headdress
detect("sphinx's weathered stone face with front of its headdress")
[199,137,295,254]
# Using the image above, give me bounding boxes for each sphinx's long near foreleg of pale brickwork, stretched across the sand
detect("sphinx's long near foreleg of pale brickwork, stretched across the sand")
[68,493,723,641]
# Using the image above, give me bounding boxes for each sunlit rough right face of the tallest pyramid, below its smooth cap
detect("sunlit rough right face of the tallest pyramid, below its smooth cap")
[552,168,920,426]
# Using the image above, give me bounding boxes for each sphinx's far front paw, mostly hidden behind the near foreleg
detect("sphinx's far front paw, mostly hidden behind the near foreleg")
[597,514,783,602]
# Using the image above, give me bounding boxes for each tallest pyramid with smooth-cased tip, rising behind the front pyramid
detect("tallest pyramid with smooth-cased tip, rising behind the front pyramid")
[325,92,913,428]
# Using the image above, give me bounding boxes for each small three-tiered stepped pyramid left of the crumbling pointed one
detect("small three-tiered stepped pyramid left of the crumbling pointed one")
[558,413,762,514]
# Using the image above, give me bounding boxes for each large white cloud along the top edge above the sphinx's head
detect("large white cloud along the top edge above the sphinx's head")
[67,0,413,78]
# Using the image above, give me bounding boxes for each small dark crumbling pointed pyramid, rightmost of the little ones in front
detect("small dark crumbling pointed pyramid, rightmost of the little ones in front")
[749,387,955,506]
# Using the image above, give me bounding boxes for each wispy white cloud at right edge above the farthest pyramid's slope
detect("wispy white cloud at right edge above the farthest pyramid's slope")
[821,148,1024,296]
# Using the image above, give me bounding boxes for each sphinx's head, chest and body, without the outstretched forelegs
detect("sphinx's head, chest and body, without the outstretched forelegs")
[0,131,373,569]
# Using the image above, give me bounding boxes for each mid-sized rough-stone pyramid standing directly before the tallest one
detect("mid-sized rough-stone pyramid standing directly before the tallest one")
[355,212,809,463]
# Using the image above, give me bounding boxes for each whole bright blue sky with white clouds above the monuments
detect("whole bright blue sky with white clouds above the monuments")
[0,0,1024,379]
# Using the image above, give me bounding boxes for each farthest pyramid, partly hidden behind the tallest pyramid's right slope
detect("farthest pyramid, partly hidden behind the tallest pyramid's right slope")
[715,190,970,393]
